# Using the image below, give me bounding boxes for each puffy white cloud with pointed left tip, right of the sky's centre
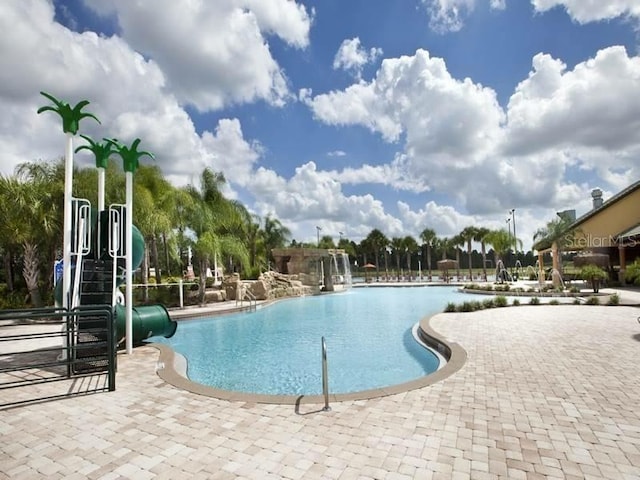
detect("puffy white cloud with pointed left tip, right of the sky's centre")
[305,50,504,191]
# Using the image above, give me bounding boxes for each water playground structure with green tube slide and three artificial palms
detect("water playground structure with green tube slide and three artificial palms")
[38,92,176,353]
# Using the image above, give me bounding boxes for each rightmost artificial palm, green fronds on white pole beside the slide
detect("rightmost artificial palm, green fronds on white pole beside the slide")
[105,138,154,354]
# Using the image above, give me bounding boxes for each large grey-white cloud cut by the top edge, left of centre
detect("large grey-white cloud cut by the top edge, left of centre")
[84,0,312,111]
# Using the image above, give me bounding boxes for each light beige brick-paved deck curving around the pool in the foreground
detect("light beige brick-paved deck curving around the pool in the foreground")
[0,306,640,480]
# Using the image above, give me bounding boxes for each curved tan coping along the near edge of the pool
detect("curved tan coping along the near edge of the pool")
[148,313,467,405]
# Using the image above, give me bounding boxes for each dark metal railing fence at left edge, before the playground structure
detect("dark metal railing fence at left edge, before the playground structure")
[0,305,116,408]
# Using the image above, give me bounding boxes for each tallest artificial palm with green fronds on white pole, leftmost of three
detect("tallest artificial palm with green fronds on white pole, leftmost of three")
[38,92,100,308]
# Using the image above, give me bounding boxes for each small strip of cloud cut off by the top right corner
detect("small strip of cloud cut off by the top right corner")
[531,0,640,23]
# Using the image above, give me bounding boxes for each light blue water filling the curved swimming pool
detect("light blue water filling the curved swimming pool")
[153,287,473,395]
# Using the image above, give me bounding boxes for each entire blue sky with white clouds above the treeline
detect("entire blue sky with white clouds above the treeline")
[0,0,640,247]
